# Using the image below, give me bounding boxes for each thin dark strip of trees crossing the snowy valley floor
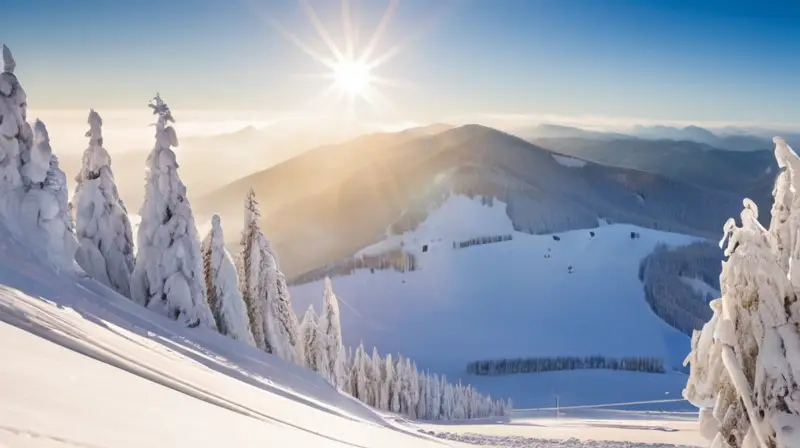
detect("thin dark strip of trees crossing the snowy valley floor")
[467,355,665,376]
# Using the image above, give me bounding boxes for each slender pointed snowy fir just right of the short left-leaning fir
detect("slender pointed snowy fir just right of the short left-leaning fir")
[236,189,272,353]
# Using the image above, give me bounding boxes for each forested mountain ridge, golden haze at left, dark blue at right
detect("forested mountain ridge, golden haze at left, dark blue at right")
[193,125,774,276]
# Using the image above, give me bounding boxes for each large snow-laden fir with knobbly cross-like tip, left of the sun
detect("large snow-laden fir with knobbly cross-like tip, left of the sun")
[131,95,216,328]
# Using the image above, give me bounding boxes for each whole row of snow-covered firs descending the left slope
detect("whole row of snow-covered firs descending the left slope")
[0,51,508,419]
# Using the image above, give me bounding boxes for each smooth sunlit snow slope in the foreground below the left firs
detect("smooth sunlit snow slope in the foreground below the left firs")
[0,228,454,447]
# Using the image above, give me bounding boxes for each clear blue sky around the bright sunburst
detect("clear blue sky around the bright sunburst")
[2,0,800,123]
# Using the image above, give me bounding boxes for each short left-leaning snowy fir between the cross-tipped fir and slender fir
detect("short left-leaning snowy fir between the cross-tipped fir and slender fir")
[200,215,256,346]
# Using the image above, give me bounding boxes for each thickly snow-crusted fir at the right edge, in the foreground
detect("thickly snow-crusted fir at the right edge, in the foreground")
[684,138,800,448]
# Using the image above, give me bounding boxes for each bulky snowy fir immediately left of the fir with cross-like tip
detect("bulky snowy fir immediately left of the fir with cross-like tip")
[72,110,134,297]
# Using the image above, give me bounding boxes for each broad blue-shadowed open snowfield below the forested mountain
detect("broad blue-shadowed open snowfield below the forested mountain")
[291,195,697,407]
